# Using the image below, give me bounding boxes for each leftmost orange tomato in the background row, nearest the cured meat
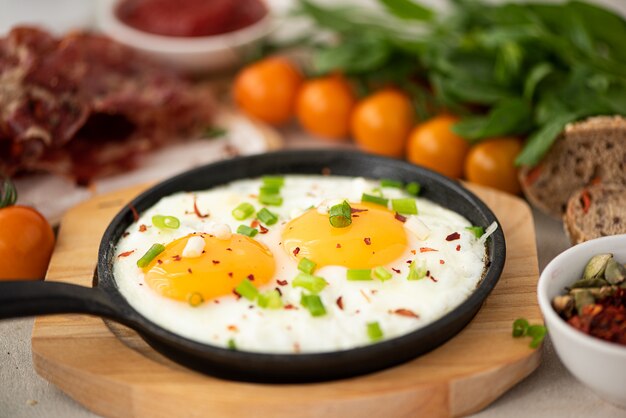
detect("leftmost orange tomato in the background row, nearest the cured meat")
[233,57,302,125]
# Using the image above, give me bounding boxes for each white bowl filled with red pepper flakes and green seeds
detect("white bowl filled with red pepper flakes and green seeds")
[537,234,626,408]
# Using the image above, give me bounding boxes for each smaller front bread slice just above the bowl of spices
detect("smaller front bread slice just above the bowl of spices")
[563,183,626,245]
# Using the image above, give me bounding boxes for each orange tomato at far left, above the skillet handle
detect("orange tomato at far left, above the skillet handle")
[0,206,54,280]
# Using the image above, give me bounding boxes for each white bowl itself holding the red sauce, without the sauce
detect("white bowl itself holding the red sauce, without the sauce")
[97,0,275,74]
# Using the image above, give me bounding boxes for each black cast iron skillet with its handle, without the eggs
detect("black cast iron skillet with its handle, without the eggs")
[0,151,506,383]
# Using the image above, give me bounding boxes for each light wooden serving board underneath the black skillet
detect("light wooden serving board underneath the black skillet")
[32,185,542,418]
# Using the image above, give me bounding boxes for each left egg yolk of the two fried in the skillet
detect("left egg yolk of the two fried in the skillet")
[144,234,275,301]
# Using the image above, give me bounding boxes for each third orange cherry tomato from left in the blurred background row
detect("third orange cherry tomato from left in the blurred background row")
[350,89,413,157]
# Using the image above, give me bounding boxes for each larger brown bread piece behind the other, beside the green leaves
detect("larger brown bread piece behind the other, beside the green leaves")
[520,116,626,218]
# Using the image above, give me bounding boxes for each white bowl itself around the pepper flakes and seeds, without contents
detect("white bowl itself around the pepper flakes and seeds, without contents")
[537,234,626,408]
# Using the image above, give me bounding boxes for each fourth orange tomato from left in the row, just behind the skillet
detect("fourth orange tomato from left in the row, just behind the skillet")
[407,115,470,178]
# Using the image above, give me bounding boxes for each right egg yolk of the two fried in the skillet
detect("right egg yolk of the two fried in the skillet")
[282,203,407,269]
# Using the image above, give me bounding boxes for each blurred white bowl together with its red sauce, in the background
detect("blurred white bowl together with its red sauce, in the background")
[98,0,274,73]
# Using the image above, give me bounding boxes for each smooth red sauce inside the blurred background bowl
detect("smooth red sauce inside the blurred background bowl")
[116,0,267,37]
